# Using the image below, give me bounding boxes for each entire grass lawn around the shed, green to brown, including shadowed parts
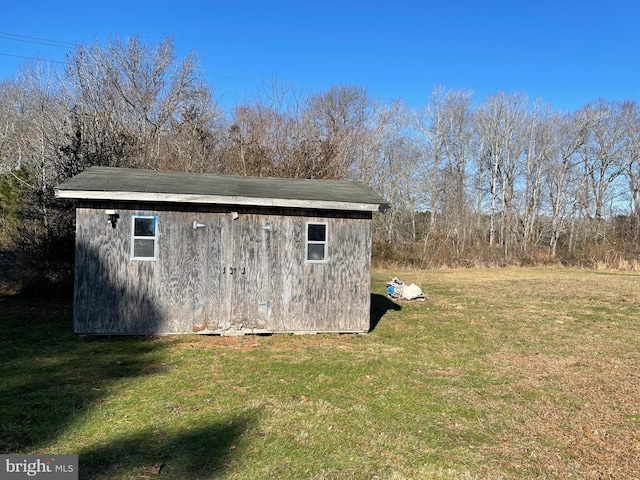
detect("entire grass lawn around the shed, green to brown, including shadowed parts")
[0,268,640,480]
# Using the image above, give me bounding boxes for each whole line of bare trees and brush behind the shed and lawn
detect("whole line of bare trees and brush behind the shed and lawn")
[0,37,640,290]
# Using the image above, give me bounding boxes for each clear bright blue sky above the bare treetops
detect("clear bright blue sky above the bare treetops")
[0,0,640,111]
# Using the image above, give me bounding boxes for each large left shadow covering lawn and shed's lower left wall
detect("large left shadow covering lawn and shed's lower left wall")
[0,238,181,453]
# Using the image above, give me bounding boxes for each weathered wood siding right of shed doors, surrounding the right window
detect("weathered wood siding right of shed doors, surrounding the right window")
[271,211,371,332]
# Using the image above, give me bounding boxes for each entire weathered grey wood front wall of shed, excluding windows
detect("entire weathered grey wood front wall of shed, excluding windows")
[75,202,371,334]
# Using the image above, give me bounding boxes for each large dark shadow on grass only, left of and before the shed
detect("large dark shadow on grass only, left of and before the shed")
[0,296,170,453]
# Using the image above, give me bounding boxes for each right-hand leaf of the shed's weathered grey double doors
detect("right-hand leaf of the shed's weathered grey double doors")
[227,214,272,330]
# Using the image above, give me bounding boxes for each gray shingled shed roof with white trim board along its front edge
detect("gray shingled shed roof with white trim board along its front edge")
[56,167,388,210]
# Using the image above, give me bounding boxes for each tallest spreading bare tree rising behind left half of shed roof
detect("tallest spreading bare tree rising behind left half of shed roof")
[65,37,219,169]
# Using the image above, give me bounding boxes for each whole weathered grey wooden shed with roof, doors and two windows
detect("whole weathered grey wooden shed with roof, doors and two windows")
[56,167,387,335]
